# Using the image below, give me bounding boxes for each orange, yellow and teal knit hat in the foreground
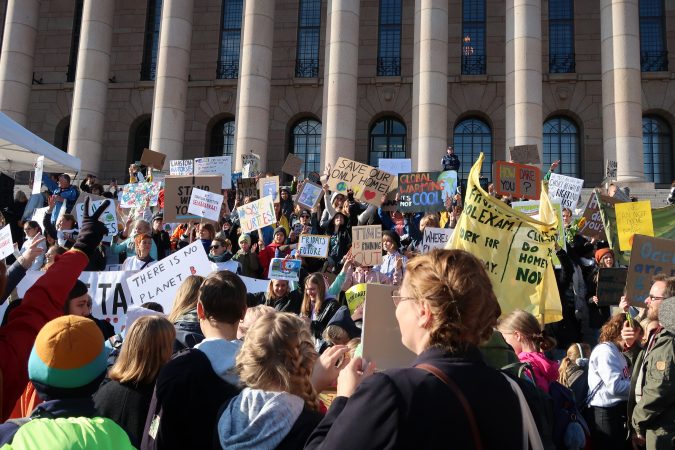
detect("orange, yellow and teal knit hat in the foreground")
[28,315,108,391]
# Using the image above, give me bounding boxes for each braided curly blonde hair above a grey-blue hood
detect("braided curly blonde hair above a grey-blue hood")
[235,313,318,411]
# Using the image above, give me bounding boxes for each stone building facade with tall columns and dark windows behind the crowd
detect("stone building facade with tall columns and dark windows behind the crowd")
[0,0,675,187]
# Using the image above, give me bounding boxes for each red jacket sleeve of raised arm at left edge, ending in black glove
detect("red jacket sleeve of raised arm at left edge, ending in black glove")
[0,250,89,422]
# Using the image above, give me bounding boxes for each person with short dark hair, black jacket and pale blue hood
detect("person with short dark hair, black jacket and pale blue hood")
[141,271,246,450]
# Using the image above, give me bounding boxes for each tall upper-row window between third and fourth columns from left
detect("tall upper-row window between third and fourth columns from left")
[216,0,244,80]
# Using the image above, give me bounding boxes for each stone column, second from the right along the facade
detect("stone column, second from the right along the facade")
[505,0,543,161]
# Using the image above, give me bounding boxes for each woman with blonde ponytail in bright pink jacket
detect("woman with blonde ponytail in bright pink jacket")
[498,309,558,392]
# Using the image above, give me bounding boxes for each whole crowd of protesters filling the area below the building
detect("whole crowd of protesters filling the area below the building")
[0,155,675,449]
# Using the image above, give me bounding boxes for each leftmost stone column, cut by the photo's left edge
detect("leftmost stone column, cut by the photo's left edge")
[0,0,40,127]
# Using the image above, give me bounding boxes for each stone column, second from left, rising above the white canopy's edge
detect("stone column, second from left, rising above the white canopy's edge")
[68,0,115,177]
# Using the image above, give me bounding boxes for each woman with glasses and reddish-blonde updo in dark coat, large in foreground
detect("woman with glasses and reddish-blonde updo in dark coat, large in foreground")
[305,250,529,449]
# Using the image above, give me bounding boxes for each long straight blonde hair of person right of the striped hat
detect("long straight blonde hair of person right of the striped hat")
[108,316,176,384]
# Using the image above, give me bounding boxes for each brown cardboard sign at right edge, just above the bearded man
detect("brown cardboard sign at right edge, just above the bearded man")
[626,234,675,307]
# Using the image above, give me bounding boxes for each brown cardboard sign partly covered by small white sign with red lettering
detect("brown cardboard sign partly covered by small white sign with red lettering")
[164,175,221,223]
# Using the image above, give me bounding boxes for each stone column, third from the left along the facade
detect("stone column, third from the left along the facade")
[150,0,193,167]
